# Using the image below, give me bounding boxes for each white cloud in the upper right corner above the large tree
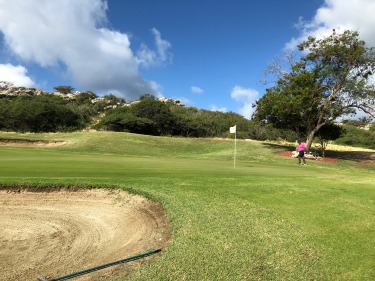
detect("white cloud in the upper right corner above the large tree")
[285,0,375,49]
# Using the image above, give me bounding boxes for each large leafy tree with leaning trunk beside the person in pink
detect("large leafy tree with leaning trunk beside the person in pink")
[254,30,375,150]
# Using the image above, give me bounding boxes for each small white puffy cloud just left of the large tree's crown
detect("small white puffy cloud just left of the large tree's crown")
[231,86,259,119]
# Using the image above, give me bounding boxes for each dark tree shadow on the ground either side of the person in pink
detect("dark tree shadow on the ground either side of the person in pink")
[263,143,375,162]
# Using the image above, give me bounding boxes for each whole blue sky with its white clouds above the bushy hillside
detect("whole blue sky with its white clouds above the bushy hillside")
[0,0,375,118]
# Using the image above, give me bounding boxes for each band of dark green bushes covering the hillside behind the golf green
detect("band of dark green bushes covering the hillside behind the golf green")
[0,82,375,148]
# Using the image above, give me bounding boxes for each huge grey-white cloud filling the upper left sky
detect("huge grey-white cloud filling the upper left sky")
[0,0,170,99]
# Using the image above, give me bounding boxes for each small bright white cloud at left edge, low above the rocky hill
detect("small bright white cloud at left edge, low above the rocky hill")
[0,64,35,88]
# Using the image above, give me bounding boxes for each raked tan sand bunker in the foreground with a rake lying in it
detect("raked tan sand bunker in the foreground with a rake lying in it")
[0,189,170,281]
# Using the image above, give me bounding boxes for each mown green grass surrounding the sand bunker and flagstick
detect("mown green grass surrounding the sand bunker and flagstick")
[0,132,375,280]
